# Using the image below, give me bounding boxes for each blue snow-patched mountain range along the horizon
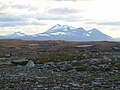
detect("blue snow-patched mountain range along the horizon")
[0,24,112,41]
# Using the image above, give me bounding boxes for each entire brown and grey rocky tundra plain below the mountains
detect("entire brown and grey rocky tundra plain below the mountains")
[0,40,120,90]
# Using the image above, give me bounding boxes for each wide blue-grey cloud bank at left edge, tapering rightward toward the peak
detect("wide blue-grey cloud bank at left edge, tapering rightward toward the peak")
[0,14,46,27]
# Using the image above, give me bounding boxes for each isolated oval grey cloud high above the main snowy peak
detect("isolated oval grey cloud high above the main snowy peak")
[48,8,80,15]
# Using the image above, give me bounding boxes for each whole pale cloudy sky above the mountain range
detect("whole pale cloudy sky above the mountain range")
[0,0,120,38]
